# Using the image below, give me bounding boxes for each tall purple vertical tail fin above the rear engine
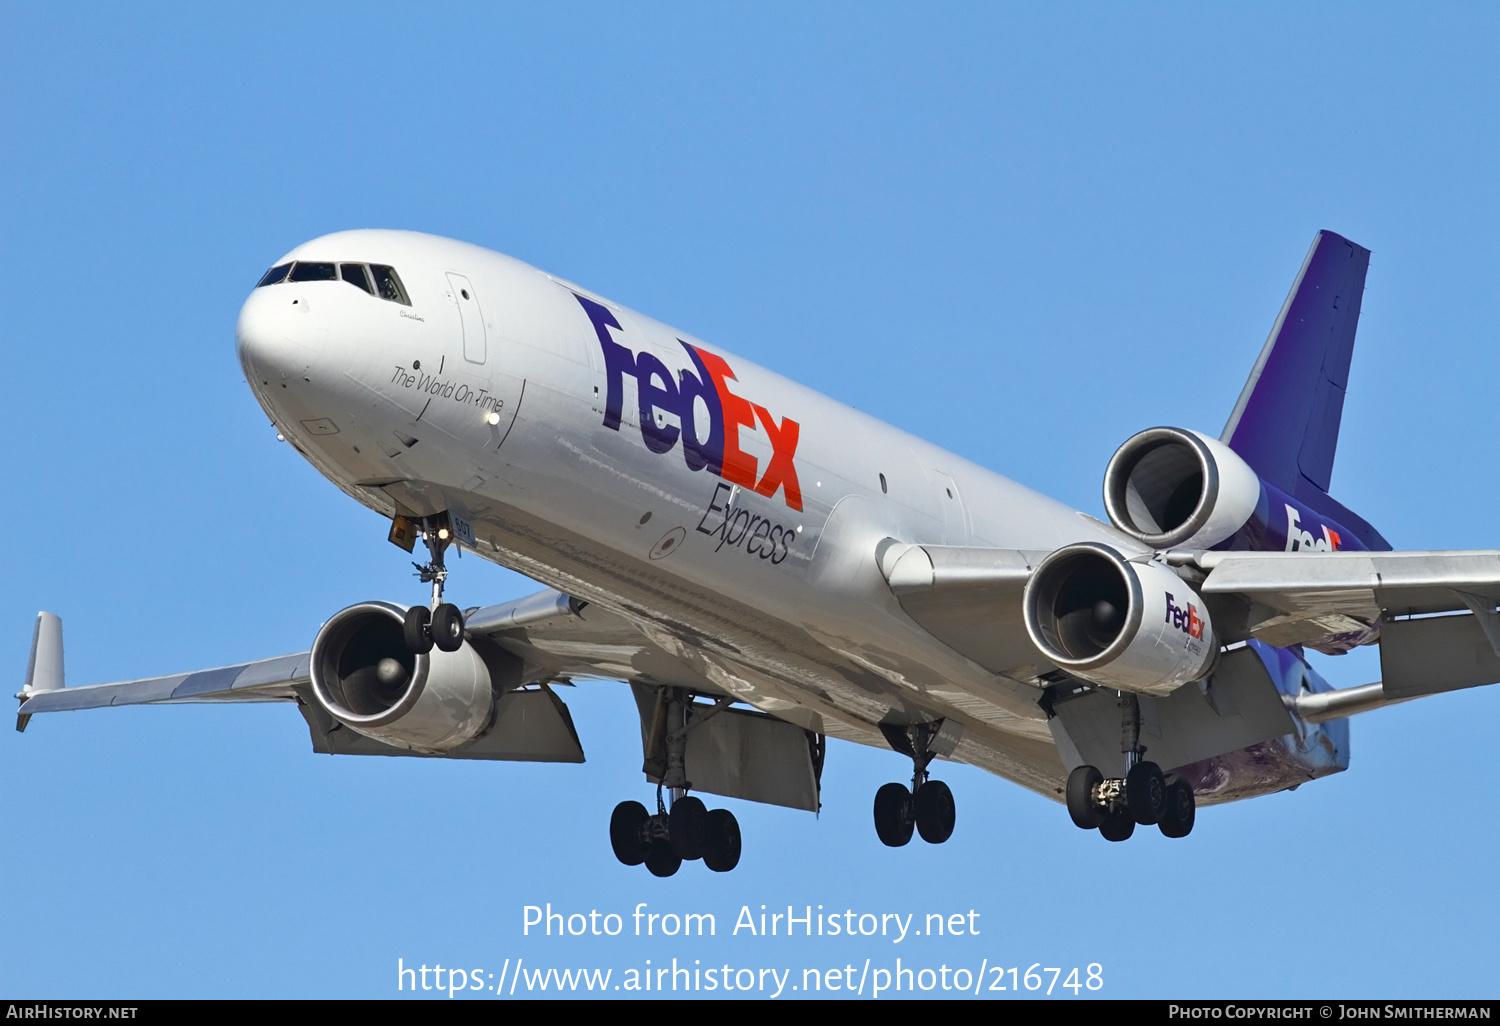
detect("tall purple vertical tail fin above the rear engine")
[1220,231,1391,549]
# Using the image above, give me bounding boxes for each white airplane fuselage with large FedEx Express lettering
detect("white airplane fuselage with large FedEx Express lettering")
[237,231,1142,798]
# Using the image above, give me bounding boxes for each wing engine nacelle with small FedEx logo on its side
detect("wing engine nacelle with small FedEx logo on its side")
[1022,542,1218,695]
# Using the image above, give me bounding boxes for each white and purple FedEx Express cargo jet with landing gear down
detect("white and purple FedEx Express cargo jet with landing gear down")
[17,230,1500,876]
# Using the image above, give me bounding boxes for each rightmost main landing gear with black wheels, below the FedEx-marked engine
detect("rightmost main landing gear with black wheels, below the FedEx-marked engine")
[1068,692,1197,842]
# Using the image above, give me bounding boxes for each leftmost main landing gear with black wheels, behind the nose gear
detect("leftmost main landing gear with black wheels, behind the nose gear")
[609,687,740,876]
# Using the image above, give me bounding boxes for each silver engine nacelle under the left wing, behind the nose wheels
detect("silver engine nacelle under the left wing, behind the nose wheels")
[312,602,495,753]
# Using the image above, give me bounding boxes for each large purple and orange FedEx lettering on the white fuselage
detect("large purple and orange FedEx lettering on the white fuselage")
[575,294,803,510]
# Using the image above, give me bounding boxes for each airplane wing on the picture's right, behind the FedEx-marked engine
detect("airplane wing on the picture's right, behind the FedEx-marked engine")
[876,540,1500,705]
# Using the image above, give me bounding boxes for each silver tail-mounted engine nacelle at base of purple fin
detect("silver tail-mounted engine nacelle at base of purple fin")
[1104,428,1262,549]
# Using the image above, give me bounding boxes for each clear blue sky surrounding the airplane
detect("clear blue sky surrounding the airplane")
[0,3,1500,1001]
